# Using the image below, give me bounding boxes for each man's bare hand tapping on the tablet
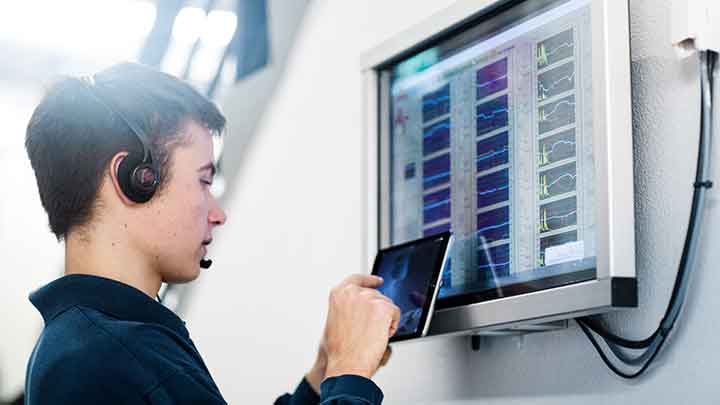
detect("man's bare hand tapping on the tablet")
[320,274,400,381]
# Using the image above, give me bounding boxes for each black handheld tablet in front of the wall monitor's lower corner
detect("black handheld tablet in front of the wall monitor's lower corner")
[372,232,452,342]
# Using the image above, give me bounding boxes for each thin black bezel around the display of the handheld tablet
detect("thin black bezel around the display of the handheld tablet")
[371,231,452,343]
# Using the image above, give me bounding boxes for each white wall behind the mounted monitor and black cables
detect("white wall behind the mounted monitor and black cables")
[186,0,720,405]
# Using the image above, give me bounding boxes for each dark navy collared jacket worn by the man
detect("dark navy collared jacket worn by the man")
[25,275,383,405]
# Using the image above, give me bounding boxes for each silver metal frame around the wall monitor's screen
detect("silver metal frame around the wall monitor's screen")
[362,0,637,336]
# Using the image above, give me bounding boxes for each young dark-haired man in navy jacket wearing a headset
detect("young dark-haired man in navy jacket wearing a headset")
[25,64,399,404]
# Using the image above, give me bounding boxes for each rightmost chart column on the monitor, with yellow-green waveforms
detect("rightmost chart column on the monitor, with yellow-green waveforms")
[536,27,581,267]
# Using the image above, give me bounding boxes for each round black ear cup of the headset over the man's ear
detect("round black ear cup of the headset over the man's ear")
[117,153,160,203]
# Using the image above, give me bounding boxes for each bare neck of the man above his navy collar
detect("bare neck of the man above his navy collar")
[65,229,162,299]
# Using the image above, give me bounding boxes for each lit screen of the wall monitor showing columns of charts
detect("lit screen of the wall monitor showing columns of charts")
[381,0,596,308]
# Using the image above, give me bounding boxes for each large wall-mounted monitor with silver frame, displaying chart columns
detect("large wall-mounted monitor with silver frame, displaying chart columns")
[363,0,637,335]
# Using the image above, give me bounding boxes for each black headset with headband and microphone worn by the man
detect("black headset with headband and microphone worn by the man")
[80,75,212,269]
